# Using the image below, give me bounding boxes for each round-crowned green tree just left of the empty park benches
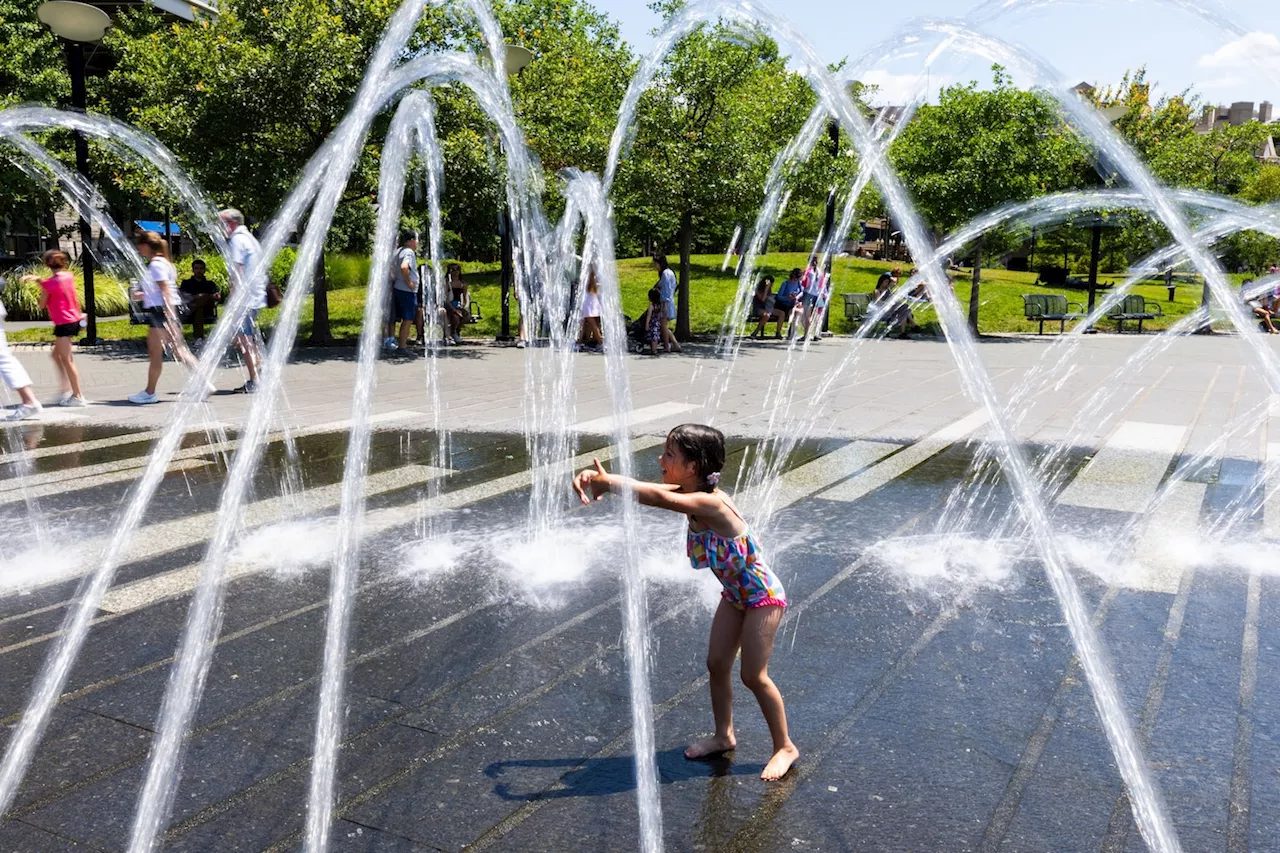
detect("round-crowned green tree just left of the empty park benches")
[890,65,1087,334]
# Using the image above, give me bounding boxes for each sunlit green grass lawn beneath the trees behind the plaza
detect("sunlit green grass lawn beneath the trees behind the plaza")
[9,252,1234,343]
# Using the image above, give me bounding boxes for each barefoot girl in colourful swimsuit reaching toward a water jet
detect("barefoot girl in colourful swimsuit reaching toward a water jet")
[573,424,800,781]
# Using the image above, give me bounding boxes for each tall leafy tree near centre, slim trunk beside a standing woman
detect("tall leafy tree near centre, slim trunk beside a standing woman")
[616,0,815,339]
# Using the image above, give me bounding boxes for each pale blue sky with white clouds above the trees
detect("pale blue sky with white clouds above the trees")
[594,0,1280,109]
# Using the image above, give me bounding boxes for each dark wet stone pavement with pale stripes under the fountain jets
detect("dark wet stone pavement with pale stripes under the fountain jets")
[0,335,1280,853]
